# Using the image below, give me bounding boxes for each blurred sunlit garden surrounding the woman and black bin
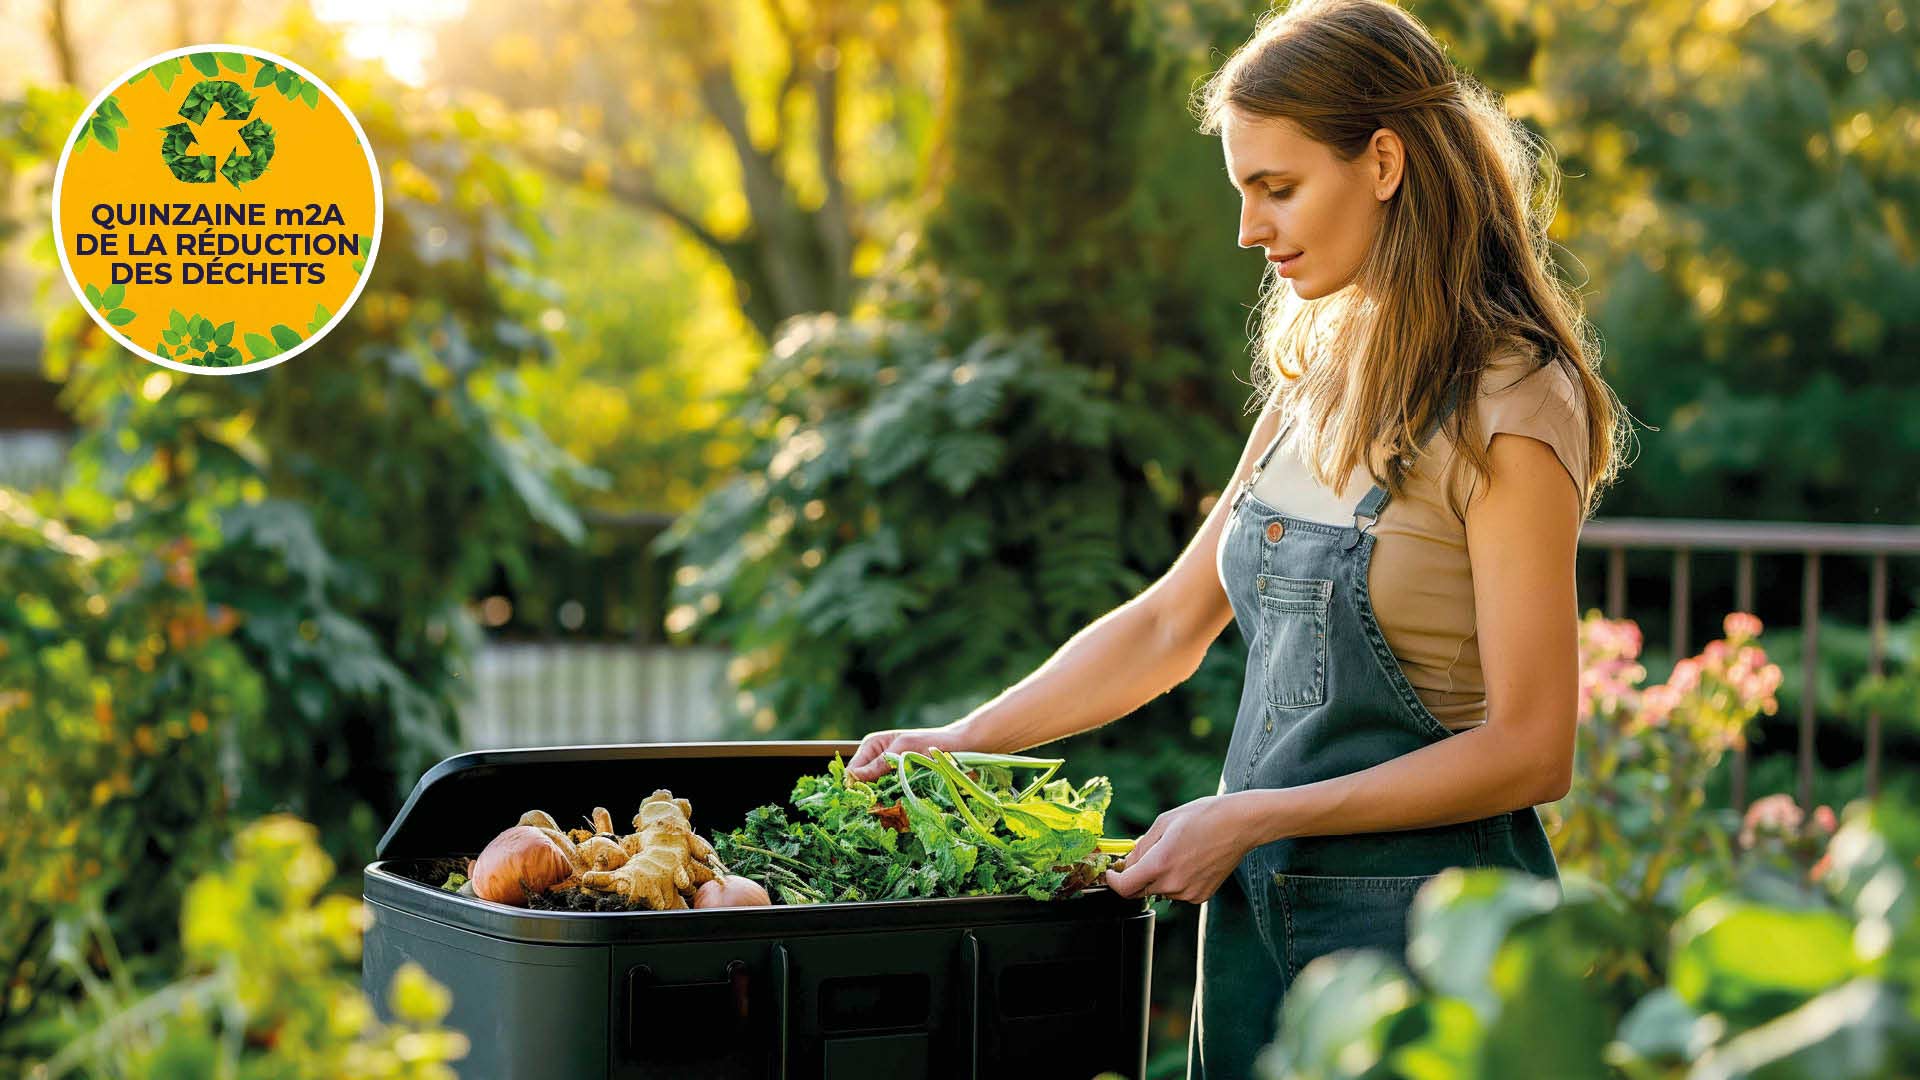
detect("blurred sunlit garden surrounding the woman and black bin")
[0,0,1920,1076]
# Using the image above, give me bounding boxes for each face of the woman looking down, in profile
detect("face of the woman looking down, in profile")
[1221,110,1402,300]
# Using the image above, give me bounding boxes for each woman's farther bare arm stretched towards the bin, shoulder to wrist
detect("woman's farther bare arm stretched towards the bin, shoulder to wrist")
[958,390,1279,753]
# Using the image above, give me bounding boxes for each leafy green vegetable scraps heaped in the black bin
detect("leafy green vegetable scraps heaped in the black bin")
[714,749,1133,903]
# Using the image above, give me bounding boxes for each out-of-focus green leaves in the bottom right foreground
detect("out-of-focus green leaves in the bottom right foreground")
[1261,799,1920,1080]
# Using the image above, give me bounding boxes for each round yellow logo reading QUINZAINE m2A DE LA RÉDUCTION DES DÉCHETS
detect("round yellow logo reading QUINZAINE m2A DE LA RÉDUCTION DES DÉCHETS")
[54,44,384,375]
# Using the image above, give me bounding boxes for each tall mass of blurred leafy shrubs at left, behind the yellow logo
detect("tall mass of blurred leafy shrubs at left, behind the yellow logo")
[0,17,579,1076]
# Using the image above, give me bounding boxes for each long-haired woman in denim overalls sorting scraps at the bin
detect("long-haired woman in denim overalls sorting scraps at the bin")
[849,0,1622,1078]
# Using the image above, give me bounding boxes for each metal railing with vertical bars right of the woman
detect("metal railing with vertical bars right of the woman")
[1580,517,1920,807]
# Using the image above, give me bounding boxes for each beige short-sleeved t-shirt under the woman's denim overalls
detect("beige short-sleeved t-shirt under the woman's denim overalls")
[1254,354,1588,730]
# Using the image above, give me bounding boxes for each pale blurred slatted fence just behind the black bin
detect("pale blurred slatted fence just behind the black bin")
[461,642,733,749]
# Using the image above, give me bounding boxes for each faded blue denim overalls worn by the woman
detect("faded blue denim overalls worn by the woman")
[1187,382,1559,1080]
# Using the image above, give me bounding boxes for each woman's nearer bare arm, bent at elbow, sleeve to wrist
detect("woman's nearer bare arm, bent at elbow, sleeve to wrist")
[1244,432,1580,844]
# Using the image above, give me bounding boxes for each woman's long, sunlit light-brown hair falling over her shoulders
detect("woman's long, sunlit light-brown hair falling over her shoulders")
[1192,0,1630,521]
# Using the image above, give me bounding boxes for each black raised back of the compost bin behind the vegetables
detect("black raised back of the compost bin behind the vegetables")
[374,740,860,859]
